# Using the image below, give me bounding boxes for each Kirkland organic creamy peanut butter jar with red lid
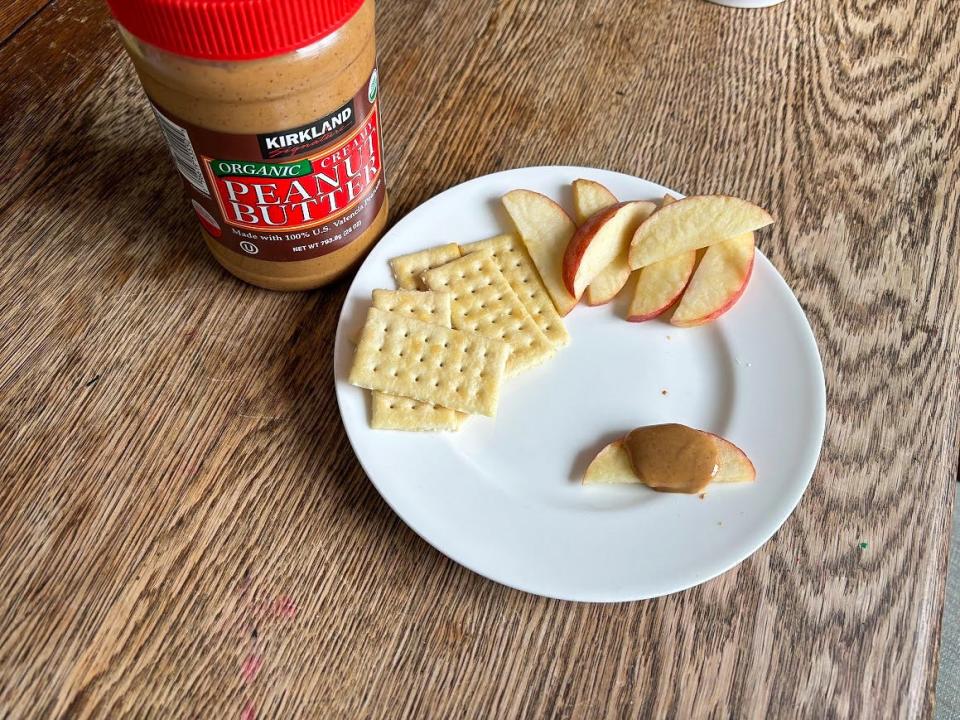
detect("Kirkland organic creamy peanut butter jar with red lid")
[107,0,388,290]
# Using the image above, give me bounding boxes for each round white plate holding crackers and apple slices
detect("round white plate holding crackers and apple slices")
[335,167,826,602]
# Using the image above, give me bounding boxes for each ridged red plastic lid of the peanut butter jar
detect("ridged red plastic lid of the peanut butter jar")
[107,0,364,60]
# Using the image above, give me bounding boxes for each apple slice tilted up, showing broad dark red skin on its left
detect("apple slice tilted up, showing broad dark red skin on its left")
[563,200,655,298]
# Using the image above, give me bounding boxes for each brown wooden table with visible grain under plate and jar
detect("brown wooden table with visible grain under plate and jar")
[0,0,960,720]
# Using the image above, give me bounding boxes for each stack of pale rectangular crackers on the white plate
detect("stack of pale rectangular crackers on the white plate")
[350,235,570,430]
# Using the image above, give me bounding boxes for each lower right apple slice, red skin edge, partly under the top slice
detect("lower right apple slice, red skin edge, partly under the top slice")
[668,232,756,327]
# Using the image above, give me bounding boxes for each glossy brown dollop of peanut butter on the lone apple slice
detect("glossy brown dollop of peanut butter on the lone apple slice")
[623,423,720,495]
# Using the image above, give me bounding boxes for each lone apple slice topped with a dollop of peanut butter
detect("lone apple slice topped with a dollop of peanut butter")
[583,423,756,495]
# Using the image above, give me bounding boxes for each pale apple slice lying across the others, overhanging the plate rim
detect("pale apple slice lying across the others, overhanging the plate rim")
[630,195,773,270]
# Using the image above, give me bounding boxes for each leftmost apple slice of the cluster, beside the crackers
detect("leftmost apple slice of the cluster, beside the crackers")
[502,190,577,315]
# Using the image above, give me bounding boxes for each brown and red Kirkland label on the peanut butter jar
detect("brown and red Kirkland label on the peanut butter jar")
[153,69,386,262]
